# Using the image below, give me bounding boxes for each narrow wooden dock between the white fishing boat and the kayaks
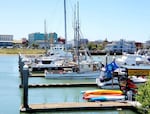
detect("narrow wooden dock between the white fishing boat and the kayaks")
[19,82,97,88]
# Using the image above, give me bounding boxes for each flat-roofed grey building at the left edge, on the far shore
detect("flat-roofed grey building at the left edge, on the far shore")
[0,35,13,48]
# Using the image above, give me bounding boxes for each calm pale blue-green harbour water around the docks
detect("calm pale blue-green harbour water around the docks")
[0,55,136,114]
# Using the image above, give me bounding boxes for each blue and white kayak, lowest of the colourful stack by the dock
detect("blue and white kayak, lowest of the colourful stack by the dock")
[88,95,125,102]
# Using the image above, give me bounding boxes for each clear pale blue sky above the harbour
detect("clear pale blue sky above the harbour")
[0,0,150,42]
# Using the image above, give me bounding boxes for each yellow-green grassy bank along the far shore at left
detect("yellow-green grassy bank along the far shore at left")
[0,48,45,54]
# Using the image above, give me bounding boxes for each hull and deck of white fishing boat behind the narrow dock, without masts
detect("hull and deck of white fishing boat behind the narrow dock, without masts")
[45,61,100,79]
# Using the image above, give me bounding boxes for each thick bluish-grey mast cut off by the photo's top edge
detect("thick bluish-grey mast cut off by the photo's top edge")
[64,0,67,51]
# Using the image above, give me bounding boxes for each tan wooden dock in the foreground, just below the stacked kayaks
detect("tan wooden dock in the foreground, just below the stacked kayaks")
[20,102,135,112]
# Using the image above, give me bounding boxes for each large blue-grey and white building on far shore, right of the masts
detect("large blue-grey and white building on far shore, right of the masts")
[104,39,136,53]
